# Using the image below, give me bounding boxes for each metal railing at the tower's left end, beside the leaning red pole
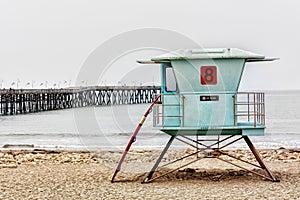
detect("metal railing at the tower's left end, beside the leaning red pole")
[153,94,184,127]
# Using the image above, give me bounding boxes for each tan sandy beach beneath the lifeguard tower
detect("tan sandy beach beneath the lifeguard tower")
[0,149,300,199]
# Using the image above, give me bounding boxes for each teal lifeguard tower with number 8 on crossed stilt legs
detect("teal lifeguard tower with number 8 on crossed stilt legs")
[111,48,277,182]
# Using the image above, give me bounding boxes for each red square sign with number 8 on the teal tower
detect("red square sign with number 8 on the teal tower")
[200,66,218,85]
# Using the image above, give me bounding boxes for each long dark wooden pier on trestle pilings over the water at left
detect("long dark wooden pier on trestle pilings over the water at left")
[0,86,160,115]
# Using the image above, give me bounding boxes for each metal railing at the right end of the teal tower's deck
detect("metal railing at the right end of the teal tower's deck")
[233,92,265,127]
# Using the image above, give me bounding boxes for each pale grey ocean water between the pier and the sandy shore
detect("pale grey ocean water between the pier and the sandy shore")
[0,91,300,150]
